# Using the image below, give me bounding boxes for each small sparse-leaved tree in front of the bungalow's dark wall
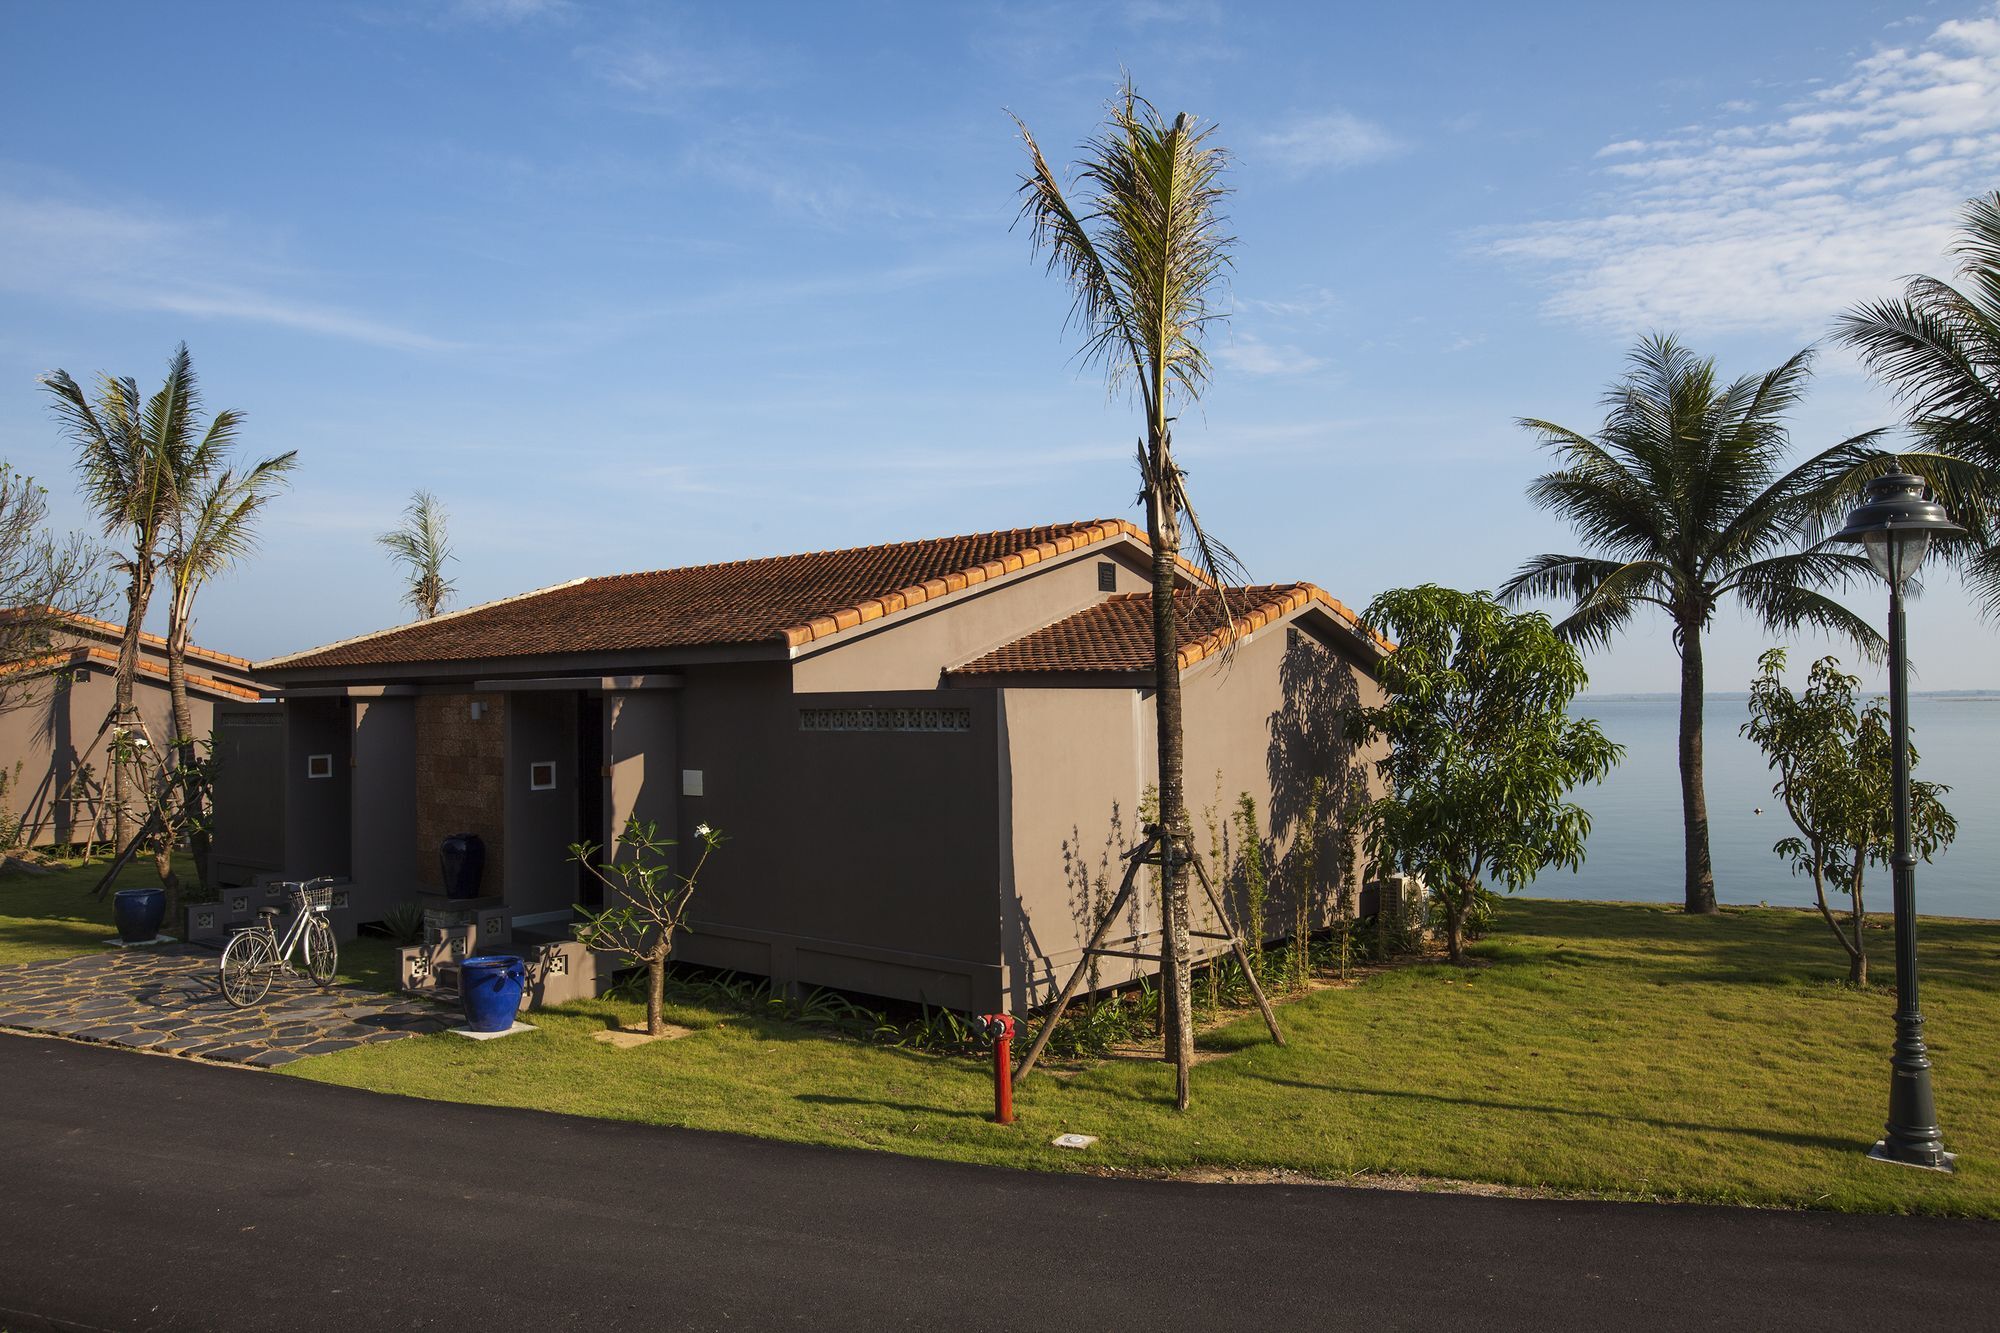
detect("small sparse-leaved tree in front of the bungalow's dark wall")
[570,815,722,1037]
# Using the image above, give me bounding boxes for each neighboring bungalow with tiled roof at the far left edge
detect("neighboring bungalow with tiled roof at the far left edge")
[0,612,262,847]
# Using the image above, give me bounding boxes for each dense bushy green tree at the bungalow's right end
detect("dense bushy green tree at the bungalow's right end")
[1354,584,1624,963]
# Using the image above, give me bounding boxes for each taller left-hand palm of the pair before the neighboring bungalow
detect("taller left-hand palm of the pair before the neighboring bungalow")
[42,342,242,851]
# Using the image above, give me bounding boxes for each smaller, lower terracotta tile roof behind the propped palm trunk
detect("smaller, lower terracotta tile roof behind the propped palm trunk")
[948,582,1388,677]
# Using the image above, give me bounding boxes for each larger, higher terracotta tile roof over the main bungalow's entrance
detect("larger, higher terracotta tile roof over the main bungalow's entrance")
[258,518,1146,671]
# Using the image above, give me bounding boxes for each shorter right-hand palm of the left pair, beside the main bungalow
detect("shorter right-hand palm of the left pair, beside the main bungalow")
[164,440,298,880]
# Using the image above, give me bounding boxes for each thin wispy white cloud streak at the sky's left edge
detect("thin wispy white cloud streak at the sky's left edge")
[0,194,452,350]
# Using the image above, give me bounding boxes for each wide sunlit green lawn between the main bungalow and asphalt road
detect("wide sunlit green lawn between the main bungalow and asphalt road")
[284,901,2000,1217]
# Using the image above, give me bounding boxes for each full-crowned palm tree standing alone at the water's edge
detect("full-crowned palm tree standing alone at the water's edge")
[1500,336,1892,913]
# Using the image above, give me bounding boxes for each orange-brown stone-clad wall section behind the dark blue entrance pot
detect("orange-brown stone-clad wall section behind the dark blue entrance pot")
[414,691,508,897]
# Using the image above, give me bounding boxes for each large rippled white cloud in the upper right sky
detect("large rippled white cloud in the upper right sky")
[1482,12,2000,336]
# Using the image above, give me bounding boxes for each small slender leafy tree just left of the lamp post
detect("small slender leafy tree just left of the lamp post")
[1742,648,1958,987]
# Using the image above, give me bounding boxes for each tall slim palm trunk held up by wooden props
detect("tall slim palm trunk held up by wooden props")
[1146,472,1194,1111]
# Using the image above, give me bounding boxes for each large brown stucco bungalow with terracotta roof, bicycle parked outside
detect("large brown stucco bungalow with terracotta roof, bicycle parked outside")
[214,520,1380,1011]
